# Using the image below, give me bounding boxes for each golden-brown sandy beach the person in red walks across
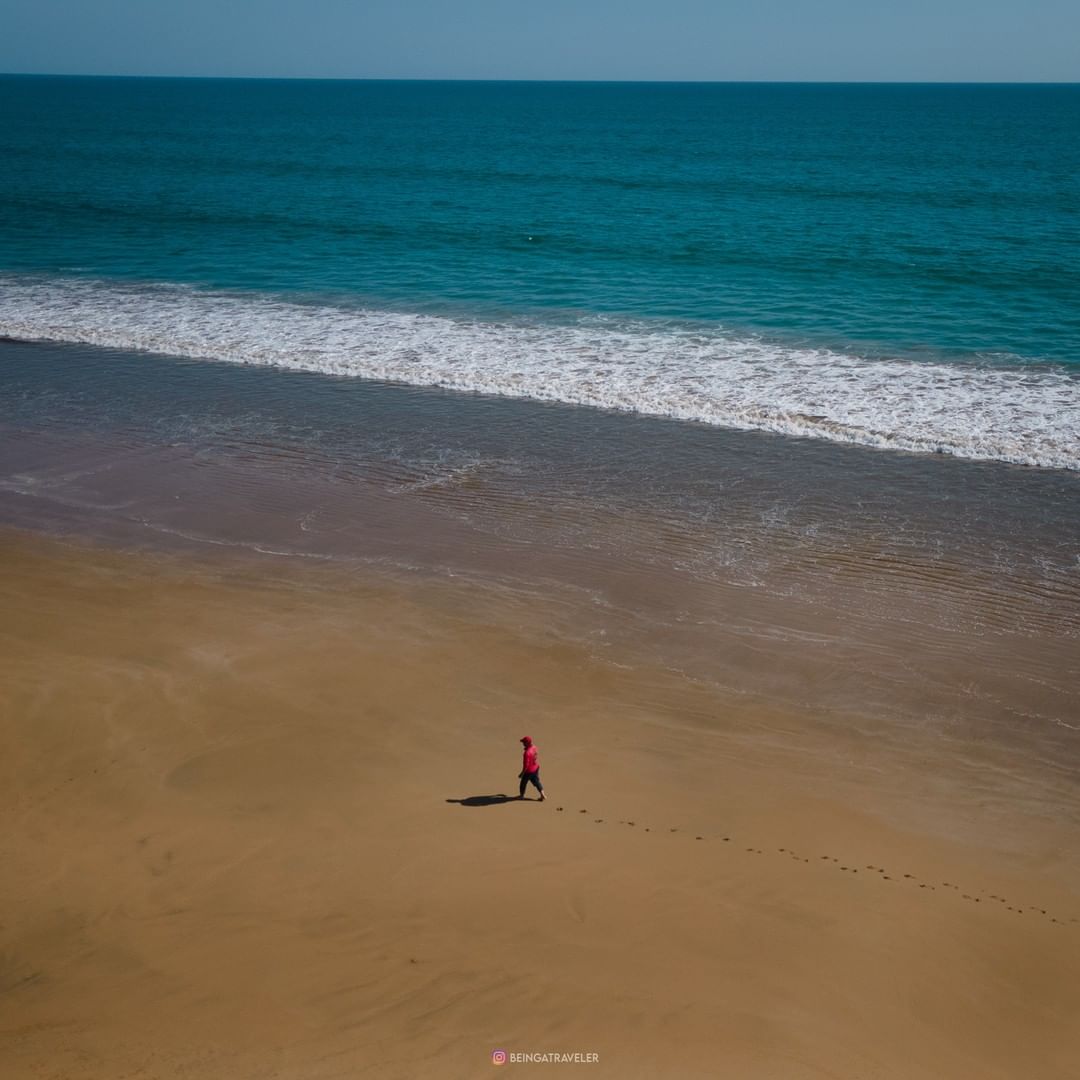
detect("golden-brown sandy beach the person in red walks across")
[0,536,1080,1080]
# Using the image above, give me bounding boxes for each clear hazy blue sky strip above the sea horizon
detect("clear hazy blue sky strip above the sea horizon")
[0,0,1080,82]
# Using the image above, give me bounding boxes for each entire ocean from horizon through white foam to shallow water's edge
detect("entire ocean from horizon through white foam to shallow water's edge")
[0,77,1080,778]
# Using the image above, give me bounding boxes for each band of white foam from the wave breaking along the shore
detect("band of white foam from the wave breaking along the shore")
[0,276,1080,469]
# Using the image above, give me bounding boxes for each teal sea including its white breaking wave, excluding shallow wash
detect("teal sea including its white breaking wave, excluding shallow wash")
[0,77,1080,469]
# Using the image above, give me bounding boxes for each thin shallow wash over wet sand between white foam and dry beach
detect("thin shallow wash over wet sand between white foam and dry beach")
[0,342,1080,779]
